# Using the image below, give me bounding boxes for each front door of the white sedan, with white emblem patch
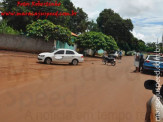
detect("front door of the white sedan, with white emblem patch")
[53,50,65,63]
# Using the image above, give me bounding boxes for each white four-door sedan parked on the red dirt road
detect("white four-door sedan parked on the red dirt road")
[38,49,84,65]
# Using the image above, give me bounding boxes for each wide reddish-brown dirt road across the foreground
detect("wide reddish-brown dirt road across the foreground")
[0,51,162,122]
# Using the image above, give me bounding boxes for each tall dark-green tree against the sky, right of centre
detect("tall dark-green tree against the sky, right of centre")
[97,9,133,48]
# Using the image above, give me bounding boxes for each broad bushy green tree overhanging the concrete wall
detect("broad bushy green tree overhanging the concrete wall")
[27,20,73,45]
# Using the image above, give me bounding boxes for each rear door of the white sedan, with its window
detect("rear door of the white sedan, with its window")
[64,50,75,63]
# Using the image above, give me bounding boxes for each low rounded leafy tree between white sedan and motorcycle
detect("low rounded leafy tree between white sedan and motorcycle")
[76,32,118,56]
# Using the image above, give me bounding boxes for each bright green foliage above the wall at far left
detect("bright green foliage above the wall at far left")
[0,20,19,35]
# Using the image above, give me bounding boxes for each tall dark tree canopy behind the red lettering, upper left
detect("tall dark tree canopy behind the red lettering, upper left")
[3,0,88,34]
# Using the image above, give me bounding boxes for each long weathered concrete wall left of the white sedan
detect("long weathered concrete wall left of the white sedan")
[0,34,54,53]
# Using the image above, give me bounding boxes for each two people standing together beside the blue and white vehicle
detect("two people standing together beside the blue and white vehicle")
[134,52,144,72]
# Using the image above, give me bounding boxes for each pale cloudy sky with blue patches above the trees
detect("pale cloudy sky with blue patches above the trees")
[71,0,163,42]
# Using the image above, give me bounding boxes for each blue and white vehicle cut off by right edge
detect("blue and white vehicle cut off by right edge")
[143,55,163,72]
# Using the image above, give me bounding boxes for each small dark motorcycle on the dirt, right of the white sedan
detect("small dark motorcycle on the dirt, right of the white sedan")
[102,56,116,66]
